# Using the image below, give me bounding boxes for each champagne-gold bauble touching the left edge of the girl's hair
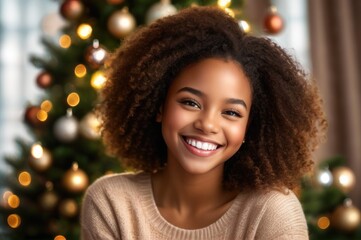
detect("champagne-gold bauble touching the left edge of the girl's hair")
[79,112,100,140]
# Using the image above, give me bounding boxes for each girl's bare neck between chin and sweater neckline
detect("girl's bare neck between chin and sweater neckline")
[152,163,236,214]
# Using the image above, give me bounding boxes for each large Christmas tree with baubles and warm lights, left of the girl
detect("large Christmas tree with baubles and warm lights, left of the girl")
[0,0,282,240]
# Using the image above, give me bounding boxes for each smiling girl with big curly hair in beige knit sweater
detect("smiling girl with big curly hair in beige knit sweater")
[81,7,326,240]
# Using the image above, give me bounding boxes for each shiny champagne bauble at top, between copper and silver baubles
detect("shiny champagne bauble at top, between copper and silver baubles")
[108,7,136,38]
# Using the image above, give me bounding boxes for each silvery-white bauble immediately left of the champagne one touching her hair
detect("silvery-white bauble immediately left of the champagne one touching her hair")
[54,110,79,142]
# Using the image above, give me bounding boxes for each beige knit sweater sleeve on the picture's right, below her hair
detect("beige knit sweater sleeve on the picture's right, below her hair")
[256,191,309,240]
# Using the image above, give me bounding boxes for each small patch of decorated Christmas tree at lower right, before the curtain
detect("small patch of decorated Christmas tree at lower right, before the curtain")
[300,157,361,240]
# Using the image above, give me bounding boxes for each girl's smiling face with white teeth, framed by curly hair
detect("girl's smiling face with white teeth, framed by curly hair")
[157,58,252,174]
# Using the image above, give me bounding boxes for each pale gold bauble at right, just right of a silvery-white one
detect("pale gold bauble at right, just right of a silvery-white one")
[332,166,356,193]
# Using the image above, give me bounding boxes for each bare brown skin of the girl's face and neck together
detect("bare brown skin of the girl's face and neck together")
[152,58,252,229]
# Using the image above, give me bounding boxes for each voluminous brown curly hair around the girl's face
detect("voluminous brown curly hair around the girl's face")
[99,7,327,189]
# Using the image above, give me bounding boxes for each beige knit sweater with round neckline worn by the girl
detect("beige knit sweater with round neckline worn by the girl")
[81,173,308,240]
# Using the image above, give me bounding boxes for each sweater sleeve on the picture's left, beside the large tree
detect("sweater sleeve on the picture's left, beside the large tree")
[80,179,120,240]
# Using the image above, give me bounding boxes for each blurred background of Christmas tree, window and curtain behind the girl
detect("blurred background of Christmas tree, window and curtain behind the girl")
[0,0,361,240]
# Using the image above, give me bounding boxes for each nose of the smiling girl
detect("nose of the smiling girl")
[194,112,220,134]
